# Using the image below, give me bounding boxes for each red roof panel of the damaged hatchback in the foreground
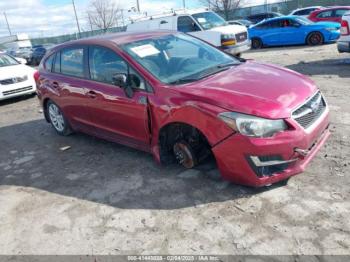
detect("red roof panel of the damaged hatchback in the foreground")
[53,30,178,50]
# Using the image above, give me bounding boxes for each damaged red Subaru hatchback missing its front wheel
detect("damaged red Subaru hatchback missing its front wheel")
[38,31,330,186]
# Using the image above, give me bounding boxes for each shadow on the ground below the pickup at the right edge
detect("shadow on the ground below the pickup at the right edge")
[286,58,350,78]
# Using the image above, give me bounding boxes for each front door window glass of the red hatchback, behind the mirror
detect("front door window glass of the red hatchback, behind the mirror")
[89,47,146,90]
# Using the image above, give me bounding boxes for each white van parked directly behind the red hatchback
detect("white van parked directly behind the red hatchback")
[126,9,251,56]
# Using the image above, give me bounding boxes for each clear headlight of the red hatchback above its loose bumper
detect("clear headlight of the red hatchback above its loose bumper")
[219,112,288,137]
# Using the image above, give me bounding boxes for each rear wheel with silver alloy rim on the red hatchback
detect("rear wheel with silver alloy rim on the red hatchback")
[46,101,72,136]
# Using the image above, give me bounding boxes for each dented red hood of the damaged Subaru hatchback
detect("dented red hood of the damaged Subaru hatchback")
[176,61,317,119]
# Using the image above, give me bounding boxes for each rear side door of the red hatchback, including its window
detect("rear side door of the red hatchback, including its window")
[50,46,91,132]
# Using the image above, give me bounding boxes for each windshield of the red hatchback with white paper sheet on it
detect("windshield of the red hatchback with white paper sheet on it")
[122,34,240,84]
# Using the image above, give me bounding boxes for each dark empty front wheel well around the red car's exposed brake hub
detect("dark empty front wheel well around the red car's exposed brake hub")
[158,123,211,164]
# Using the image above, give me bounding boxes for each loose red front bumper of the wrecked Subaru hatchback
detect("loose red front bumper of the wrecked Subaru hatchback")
[212,108,330,187]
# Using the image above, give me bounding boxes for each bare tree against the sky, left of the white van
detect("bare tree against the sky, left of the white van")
[87,0,120,31]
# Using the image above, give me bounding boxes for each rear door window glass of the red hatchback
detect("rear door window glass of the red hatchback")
[61,48,84,77]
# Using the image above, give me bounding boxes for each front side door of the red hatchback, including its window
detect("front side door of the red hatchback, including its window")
[86,46,150,149]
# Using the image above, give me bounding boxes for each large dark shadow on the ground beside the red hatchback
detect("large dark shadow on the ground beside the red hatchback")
[0,119,278,209]
